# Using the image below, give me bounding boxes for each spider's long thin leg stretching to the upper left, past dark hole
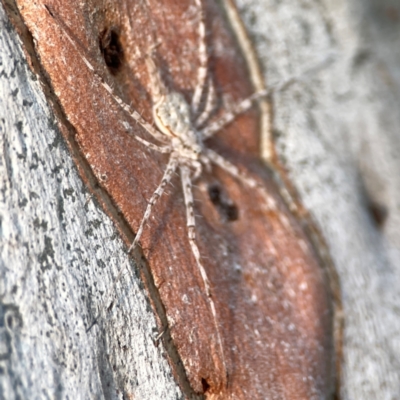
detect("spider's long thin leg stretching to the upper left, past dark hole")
[44,5,167,143]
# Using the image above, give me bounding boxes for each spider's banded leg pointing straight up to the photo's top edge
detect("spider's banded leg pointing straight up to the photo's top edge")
[191,0,208,115]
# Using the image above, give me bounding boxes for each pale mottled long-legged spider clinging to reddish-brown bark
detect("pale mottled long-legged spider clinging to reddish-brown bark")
[45,0,276,382]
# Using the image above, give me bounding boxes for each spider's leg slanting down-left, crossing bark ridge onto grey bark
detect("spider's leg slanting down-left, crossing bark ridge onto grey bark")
[87,155,178,330]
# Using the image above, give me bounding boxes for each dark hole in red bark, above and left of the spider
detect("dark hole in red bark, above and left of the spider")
[99,27,124,75]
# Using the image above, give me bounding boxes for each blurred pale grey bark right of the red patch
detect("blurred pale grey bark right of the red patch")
[238,0,400,400]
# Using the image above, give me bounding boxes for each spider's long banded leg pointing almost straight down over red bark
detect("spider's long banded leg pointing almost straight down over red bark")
[180,166,227,372]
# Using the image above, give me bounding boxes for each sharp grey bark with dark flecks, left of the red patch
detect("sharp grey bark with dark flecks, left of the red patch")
[0,4,181,400]
